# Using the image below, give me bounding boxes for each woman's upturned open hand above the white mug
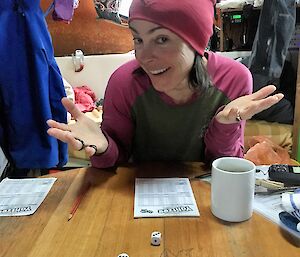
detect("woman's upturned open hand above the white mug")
[216,85,283,124]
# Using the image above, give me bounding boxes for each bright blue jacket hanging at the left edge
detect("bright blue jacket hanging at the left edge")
[0,0,67,168]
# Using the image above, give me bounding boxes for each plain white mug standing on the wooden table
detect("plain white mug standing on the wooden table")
[211,157,256,222]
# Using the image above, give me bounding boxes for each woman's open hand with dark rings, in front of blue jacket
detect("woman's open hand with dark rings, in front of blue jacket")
[47,97,108,156]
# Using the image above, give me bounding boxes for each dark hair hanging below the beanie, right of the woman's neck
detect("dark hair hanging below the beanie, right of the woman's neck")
[189,52,213,93]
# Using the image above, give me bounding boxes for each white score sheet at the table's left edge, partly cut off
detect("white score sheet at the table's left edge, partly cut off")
[0,178,57,216]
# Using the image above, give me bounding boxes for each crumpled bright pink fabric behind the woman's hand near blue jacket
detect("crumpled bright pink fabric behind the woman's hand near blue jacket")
[74,86,97,112]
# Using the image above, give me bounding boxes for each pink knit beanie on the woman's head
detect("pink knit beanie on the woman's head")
[129,0,215,55]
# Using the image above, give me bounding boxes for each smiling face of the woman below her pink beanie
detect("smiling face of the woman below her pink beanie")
[130,20,195,93]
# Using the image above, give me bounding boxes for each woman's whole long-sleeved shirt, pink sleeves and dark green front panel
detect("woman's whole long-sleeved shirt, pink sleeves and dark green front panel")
[91,52,252,168]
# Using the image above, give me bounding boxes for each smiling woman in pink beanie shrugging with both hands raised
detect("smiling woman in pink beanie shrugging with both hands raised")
[48,0,283,168]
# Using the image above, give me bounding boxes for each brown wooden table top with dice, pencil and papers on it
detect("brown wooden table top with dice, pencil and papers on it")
[0,163,300,257]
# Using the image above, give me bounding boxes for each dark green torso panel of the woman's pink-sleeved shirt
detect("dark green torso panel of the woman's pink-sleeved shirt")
[132,86,229,161]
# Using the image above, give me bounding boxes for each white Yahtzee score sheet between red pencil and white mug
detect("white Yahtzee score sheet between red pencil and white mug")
[134,178,200,218]
